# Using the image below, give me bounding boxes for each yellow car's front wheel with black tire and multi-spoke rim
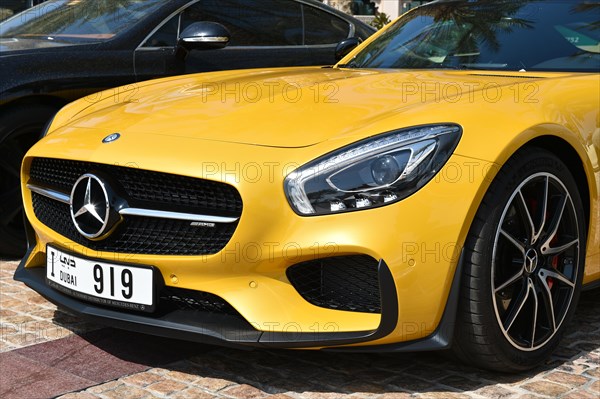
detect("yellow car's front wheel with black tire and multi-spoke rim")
[452,147,587,372]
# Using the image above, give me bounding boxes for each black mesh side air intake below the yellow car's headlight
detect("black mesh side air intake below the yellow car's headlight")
[287,255,381,313]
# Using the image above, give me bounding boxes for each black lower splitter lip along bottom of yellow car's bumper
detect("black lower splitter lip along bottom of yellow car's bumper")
[14,239,463,352]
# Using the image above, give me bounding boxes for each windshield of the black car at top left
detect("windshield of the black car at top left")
[0,0,163,43]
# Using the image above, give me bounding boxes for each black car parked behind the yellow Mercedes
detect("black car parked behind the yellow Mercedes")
[0,0,375,255]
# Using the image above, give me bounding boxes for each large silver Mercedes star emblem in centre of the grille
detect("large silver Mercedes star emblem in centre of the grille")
[71,174,111,239]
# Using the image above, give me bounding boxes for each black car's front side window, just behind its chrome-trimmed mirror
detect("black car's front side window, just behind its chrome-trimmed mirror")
[181,0,302,46]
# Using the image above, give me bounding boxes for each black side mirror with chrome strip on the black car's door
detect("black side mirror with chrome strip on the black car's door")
[177,22,231,53]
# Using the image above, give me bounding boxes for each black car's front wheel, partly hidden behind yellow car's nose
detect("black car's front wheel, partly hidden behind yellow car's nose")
[0,105,57,257]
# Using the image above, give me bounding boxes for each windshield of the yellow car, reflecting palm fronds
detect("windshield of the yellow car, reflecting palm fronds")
[345,0,600,72]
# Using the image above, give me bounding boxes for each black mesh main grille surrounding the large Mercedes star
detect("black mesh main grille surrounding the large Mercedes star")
[30,158,242,256]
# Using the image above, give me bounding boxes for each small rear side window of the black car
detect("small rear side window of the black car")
[304,6,350,45]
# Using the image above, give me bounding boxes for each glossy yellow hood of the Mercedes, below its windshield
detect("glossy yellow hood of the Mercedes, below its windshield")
[69,67,564,147]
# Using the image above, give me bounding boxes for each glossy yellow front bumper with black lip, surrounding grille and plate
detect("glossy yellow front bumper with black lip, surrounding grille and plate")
[15,131,493,350]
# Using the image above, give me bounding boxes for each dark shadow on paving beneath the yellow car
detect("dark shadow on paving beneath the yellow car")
[55,289,600,394]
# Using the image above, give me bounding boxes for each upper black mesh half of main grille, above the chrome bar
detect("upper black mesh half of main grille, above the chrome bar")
[29,158,242,217]
